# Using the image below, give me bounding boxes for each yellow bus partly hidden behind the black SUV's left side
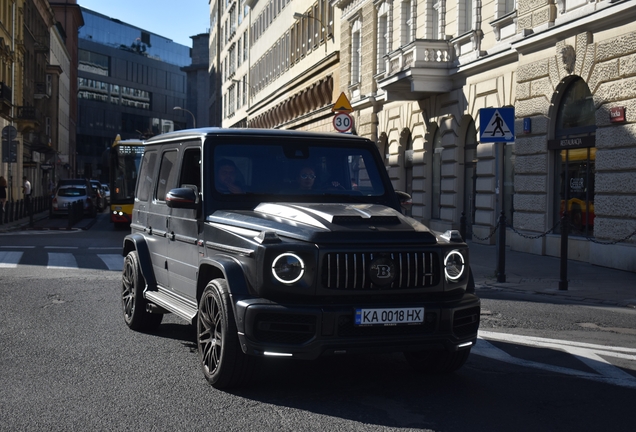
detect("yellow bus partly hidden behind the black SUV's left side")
[108,135,144,227]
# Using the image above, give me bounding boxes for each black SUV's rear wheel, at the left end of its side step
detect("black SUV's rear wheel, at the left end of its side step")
[121,251,163,331]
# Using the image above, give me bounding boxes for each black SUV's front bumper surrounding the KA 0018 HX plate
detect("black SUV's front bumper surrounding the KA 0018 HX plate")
[235,294,480,360]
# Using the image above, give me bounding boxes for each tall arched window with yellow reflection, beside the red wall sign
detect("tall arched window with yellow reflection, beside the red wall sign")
[548,77,596,236]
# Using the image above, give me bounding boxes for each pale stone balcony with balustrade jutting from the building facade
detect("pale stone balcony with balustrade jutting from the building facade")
[375,39,453,100]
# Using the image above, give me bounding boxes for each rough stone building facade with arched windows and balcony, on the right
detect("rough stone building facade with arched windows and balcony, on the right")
[332,0,636,271]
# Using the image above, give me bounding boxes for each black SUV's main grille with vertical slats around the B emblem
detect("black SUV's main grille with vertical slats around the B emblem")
[321,252,440,290]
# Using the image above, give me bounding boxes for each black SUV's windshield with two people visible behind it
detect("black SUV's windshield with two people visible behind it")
[208,138,385,199]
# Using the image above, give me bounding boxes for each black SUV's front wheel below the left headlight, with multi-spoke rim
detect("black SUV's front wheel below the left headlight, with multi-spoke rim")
[197,279,255,389]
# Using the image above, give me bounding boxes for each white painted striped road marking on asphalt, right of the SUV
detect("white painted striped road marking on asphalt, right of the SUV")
[471,330,636,388]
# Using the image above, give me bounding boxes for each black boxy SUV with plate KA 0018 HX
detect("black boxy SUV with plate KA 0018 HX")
[122,128,480,388]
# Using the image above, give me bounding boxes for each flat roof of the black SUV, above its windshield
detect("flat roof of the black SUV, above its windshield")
[145,127,368,144]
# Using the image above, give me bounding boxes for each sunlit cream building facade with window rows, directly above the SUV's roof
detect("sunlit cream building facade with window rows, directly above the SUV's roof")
[216,0,341,131]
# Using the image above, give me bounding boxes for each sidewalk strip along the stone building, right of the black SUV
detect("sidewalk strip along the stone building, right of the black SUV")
[468,241,636,308]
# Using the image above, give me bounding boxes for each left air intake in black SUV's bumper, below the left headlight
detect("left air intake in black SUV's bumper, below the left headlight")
[255,313,316,344]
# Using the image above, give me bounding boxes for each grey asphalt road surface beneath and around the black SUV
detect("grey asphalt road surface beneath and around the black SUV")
[0,215,636,431]
